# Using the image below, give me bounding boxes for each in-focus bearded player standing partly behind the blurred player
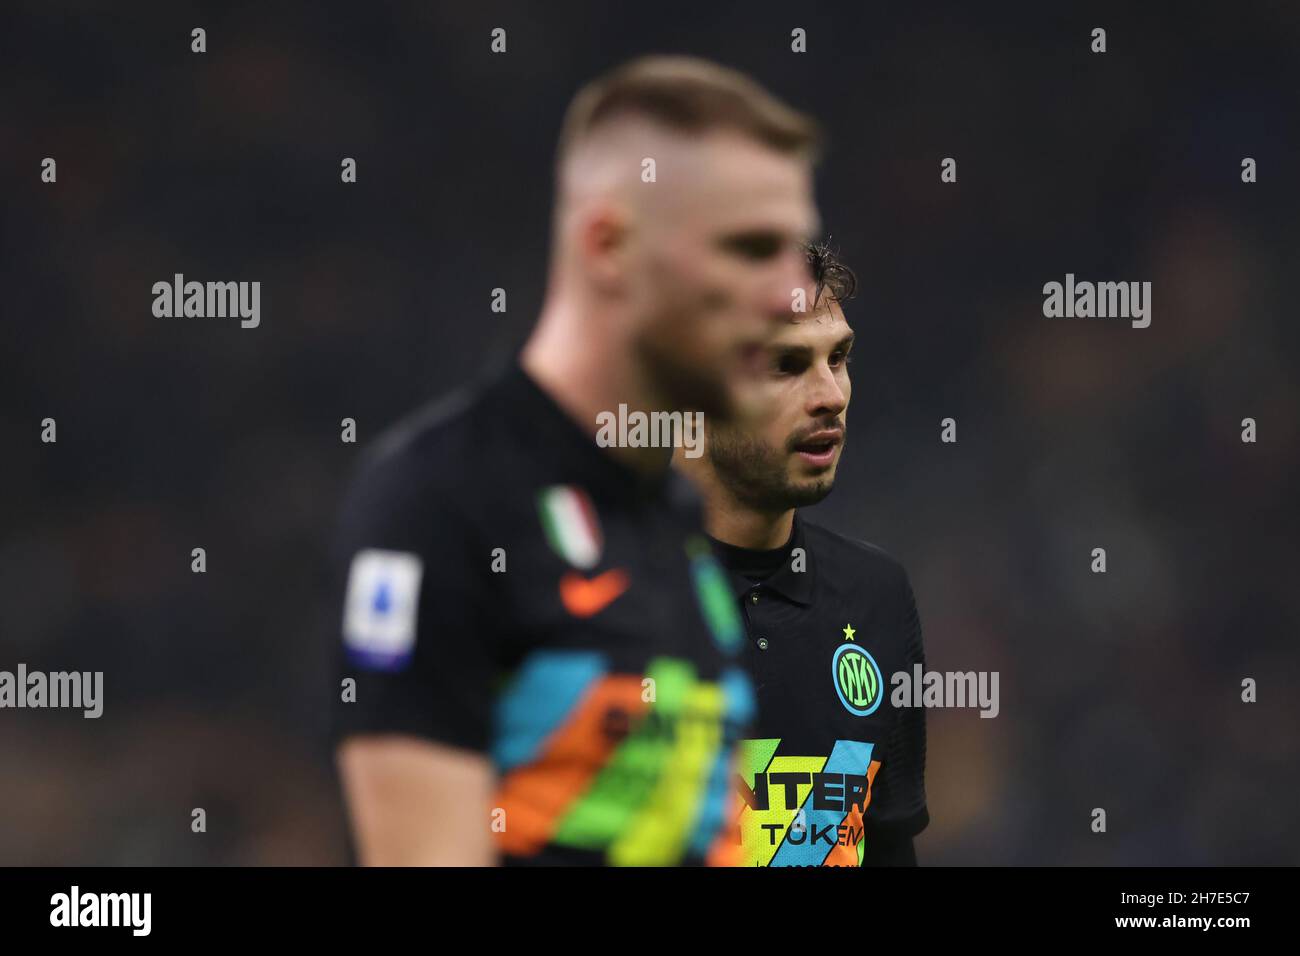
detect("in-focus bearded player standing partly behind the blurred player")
[677,245,930,866]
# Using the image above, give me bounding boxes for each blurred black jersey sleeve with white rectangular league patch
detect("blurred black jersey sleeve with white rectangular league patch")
[330,455,498,752]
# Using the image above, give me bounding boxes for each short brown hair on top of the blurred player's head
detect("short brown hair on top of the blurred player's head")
[555,56,822,170]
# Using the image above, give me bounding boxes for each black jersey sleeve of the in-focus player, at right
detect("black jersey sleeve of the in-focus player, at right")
[868,571,930,836]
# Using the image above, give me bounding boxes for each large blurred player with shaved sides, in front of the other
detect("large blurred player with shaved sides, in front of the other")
[337,57,818,865]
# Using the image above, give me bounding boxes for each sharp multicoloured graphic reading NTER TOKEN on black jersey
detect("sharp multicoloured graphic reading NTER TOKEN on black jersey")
[735,737,880,866]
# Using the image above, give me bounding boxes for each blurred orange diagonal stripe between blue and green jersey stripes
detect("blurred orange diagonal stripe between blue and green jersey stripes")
[493,675,646,856]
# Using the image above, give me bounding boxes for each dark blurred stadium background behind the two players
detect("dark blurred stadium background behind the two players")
[0,0,1300,865]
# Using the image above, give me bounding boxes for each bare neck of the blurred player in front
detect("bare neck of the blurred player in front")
[520,306,672,475]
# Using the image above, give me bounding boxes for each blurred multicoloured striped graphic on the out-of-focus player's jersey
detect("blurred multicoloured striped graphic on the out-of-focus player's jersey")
[494,652,754,866]
